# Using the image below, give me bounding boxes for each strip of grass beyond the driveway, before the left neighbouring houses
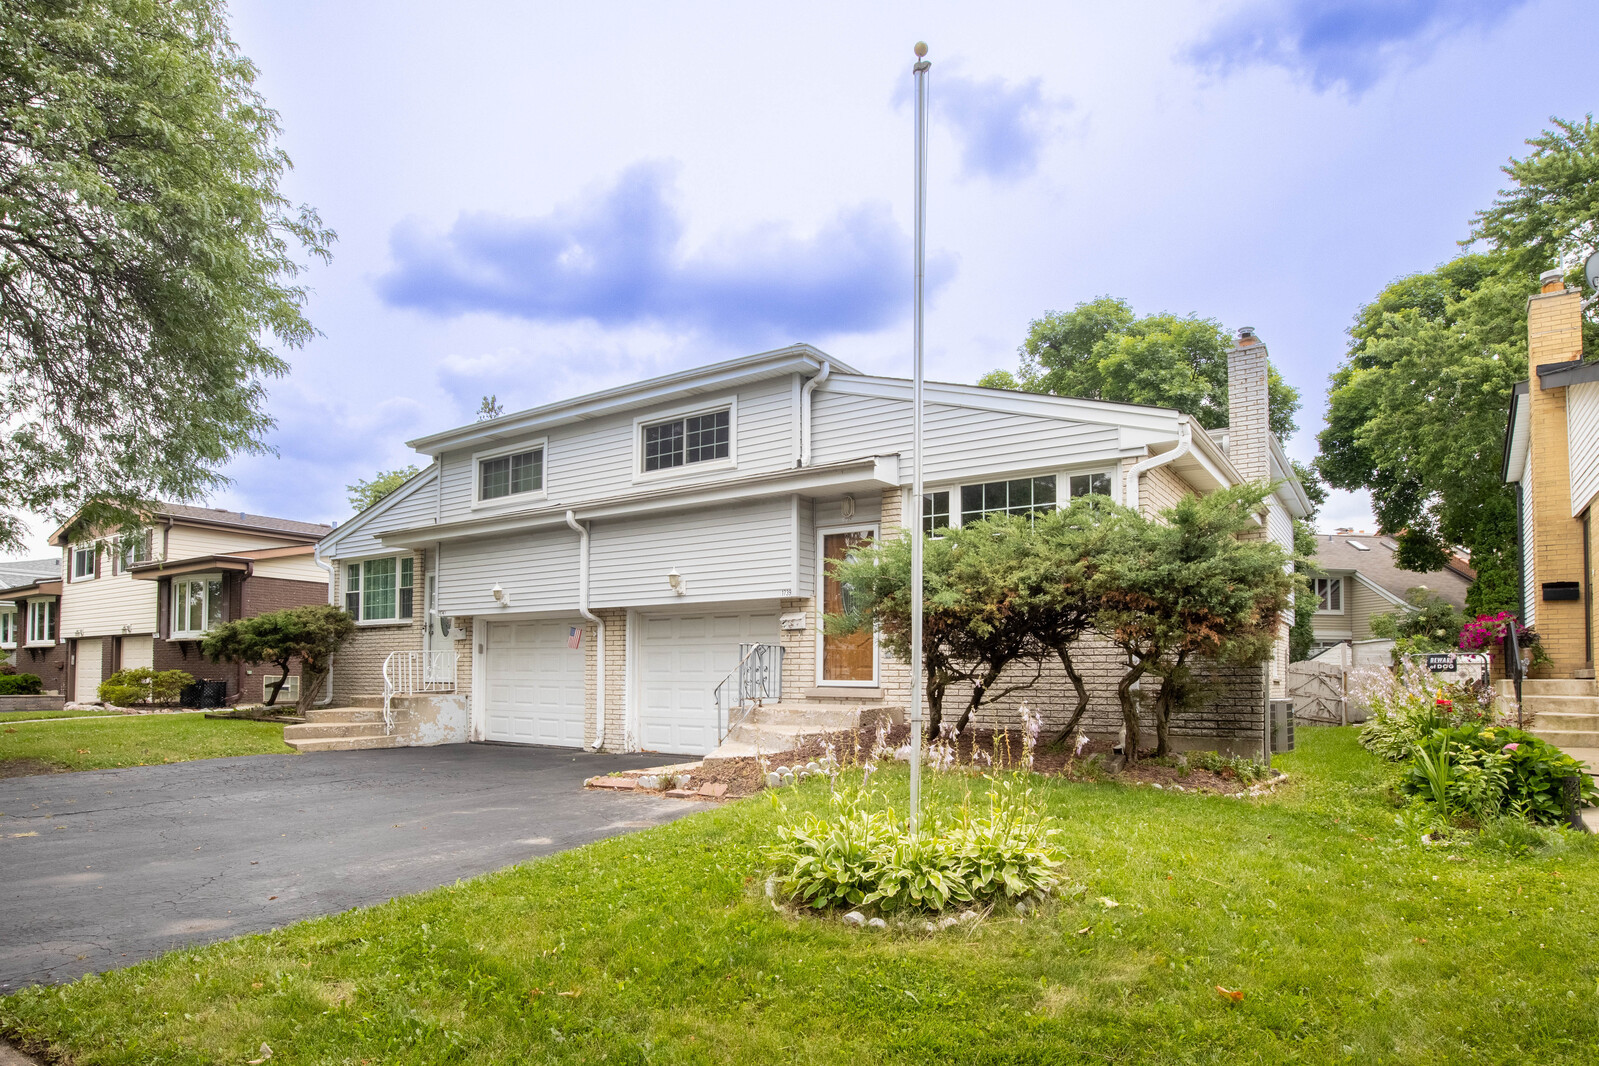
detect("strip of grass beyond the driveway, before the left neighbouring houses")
[0,714,294,774]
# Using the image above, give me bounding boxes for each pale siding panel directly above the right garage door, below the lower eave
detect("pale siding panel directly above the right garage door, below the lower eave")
[591,495,795,607]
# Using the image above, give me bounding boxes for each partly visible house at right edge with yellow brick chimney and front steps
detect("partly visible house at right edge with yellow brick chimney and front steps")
[1501,270,1599,766]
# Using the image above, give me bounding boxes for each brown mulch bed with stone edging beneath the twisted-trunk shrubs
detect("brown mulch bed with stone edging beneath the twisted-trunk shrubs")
[601,726,1273,799]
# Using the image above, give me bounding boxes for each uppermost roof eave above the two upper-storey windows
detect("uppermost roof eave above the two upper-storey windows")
[406,344,857,455]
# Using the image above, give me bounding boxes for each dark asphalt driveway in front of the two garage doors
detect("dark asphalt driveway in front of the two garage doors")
[0,745,702,994]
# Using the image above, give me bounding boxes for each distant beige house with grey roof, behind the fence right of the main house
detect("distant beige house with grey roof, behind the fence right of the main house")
[1310,529,1474,657]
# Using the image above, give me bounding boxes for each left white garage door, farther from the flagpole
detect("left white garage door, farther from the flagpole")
[483,620,584,748]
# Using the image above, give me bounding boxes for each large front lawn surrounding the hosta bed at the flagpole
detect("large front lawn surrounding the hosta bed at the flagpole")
[0,729,1599,1066]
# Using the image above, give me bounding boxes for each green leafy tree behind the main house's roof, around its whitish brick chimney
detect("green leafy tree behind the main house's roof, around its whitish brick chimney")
[977,296,1300,440]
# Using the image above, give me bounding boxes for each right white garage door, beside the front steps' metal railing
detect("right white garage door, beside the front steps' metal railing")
[638,612,779,754]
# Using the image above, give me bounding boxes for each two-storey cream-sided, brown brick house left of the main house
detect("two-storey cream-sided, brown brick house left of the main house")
[50,503,333,703]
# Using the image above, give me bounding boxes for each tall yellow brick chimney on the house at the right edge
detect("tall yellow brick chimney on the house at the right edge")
[1522,270,1588,678]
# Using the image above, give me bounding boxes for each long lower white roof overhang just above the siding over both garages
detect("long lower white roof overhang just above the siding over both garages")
[370,455,900,558]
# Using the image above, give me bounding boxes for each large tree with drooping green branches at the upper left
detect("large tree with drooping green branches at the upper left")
[0,0,334,548]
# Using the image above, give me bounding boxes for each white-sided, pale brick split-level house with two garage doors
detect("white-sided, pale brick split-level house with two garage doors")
[308,332,1308,754]
